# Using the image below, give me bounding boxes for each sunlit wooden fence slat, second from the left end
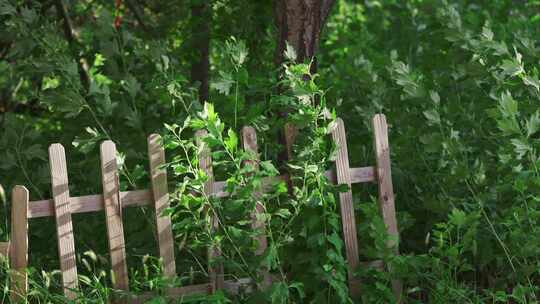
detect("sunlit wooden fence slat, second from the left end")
[49,144,77,300]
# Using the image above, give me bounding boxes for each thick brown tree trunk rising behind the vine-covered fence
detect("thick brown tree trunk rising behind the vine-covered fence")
[274,0,334,71]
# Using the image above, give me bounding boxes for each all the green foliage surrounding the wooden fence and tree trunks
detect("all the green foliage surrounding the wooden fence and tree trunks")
[0,0,540,303]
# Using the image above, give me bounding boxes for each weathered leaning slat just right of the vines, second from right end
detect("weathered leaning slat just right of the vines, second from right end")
[332,118,360,297]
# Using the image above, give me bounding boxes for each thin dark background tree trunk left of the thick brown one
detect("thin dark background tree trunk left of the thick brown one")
[191,1,212,102]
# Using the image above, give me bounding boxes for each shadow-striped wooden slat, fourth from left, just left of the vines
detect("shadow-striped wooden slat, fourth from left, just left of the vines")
[148,134,176,278]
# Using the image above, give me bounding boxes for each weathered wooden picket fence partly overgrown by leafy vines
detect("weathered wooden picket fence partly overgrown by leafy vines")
[0,114,396,303]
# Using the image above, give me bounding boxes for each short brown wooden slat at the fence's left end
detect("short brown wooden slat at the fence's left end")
[10,186,29,303]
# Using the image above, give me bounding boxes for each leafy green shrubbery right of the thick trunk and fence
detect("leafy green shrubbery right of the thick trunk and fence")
[319,1,540,303]
